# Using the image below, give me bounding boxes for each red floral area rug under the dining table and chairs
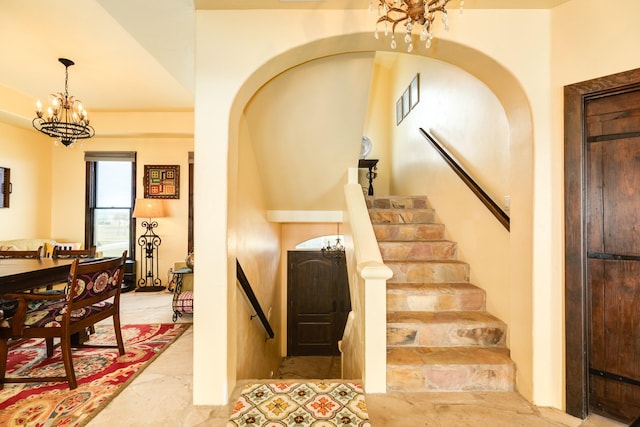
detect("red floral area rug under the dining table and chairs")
[0,323,190,427]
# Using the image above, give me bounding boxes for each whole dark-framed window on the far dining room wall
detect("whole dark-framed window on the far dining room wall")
[85,152,136,259]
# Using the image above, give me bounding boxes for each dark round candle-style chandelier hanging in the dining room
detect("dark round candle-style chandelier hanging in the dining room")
[33,58,95,146]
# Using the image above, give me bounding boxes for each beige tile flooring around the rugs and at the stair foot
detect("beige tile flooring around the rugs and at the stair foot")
[89,292,623,427]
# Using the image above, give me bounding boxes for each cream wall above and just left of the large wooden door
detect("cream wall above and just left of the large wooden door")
[548,0,640,412]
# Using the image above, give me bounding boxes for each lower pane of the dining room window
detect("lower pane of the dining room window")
[93,209,133,257]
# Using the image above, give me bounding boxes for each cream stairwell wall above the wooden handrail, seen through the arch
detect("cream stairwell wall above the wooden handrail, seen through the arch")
[384,54,510,205]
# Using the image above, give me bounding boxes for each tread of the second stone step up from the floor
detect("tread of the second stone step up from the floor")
[387,311,506,327]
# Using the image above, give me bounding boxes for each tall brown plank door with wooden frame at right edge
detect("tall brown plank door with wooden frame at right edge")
[564,68,640,425]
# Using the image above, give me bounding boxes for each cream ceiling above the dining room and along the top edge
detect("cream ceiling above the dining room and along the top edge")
[0,0,569,112]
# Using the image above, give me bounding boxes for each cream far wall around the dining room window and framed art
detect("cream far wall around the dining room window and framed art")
[51,112,192,283]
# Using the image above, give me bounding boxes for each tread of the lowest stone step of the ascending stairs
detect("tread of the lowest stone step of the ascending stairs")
[387,347,514,367]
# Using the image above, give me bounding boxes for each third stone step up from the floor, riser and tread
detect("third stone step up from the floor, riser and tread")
[387,282,486,311]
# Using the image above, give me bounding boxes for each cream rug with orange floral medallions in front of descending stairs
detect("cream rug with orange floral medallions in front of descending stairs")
[227,382,371,427]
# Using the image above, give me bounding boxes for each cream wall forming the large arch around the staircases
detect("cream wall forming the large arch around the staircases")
[194,9,552,407]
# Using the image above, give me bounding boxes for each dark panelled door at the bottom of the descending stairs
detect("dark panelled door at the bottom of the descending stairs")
[287,251,351,356]
